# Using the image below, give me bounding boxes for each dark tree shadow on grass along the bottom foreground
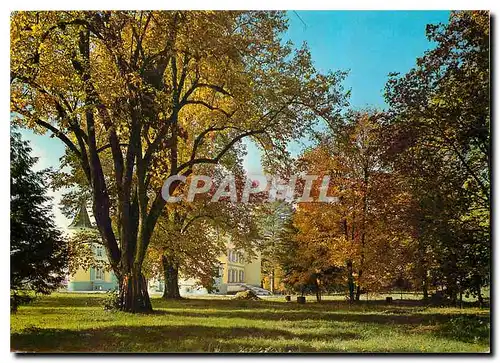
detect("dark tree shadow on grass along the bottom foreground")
[11,325,361,353]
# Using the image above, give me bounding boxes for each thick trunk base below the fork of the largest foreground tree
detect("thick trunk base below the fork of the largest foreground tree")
[119,271,153,313]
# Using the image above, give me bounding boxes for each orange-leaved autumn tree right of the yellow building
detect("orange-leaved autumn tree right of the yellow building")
[294,111,408,301]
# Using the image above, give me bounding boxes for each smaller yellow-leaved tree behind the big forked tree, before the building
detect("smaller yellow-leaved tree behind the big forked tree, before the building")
[148,165,258,299]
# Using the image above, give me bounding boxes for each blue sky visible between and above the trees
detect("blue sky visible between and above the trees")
[18,11,449,227]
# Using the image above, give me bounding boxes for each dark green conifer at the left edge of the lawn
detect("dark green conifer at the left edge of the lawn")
[10,131,67,311]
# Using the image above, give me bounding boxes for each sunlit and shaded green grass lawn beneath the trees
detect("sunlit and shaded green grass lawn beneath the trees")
[11,293,490,353]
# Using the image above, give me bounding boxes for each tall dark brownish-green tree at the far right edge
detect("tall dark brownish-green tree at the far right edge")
[386,11,491,300]
